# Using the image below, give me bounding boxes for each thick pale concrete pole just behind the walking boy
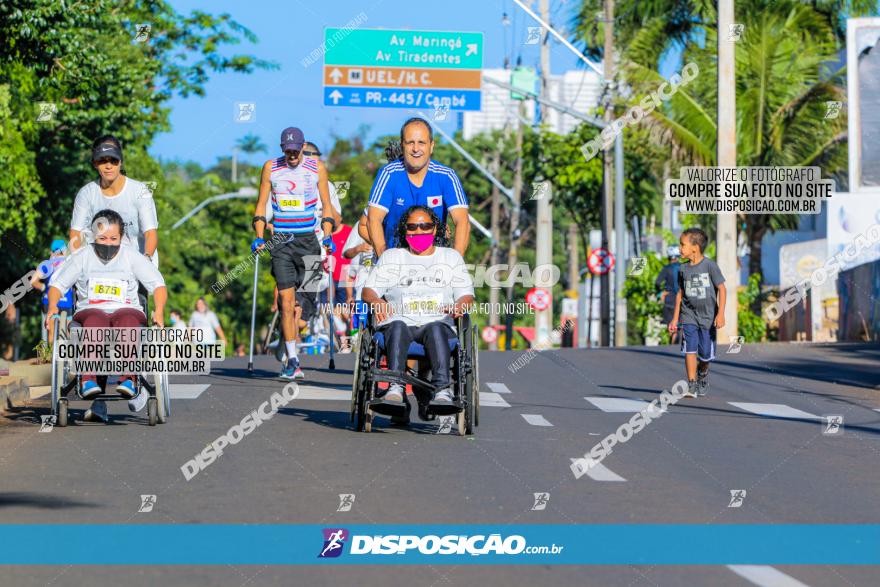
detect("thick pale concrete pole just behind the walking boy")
[716,0,739,344]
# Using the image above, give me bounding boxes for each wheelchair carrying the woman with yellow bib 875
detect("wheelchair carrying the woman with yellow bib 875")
[52,305,171,428]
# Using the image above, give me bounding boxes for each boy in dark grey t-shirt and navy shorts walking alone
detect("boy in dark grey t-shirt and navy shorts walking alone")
[669,228,727,397]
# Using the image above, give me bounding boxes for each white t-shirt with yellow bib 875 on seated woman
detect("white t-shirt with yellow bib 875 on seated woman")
[49,244,165,314]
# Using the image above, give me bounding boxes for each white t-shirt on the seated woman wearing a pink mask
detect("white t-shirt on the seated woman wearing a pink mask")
[364,247,474,327]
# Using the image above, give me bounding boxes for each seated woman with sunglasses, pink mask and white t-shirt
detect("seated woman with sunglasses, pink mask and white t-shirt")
[362,206,474,406]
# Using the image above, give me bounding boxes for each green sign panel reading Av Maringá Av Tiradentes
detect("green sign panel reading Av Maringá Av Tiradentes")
[324,28,483,69]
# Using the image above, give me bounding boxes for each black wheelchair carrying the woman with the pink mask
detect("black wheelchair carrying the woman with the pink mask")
[351,314,480,436]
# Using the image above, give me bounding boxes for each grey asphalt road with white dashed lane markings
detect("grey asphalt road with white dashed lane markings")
[0,344,880,587]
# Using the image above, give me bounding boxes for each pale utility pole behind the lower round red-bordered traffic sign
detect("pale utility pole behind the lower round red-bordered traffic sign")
[535,0,553,349]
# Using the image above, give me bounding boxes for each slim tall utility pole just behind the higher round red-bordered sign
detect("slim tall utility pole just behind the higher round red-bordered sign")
[599,0,620,346]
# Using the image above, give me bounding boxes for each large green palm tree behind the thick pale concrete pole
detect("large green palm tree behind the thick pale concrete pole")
[625,0,847,294]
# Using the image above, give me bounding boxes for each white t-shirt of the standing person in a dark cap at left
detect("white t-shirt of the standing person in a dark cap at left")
[70,176,159,253]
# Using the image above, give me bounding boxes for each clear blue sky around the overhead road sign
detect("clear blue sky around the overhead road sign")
[150,0,608,165]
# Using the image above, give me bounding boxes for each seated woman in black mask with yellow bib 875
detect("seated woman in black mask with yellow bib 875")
[46,210,168,420]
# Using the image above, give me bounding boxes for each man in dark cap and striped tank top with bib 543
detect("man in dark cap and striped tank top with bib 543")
[251,127,342,379]
